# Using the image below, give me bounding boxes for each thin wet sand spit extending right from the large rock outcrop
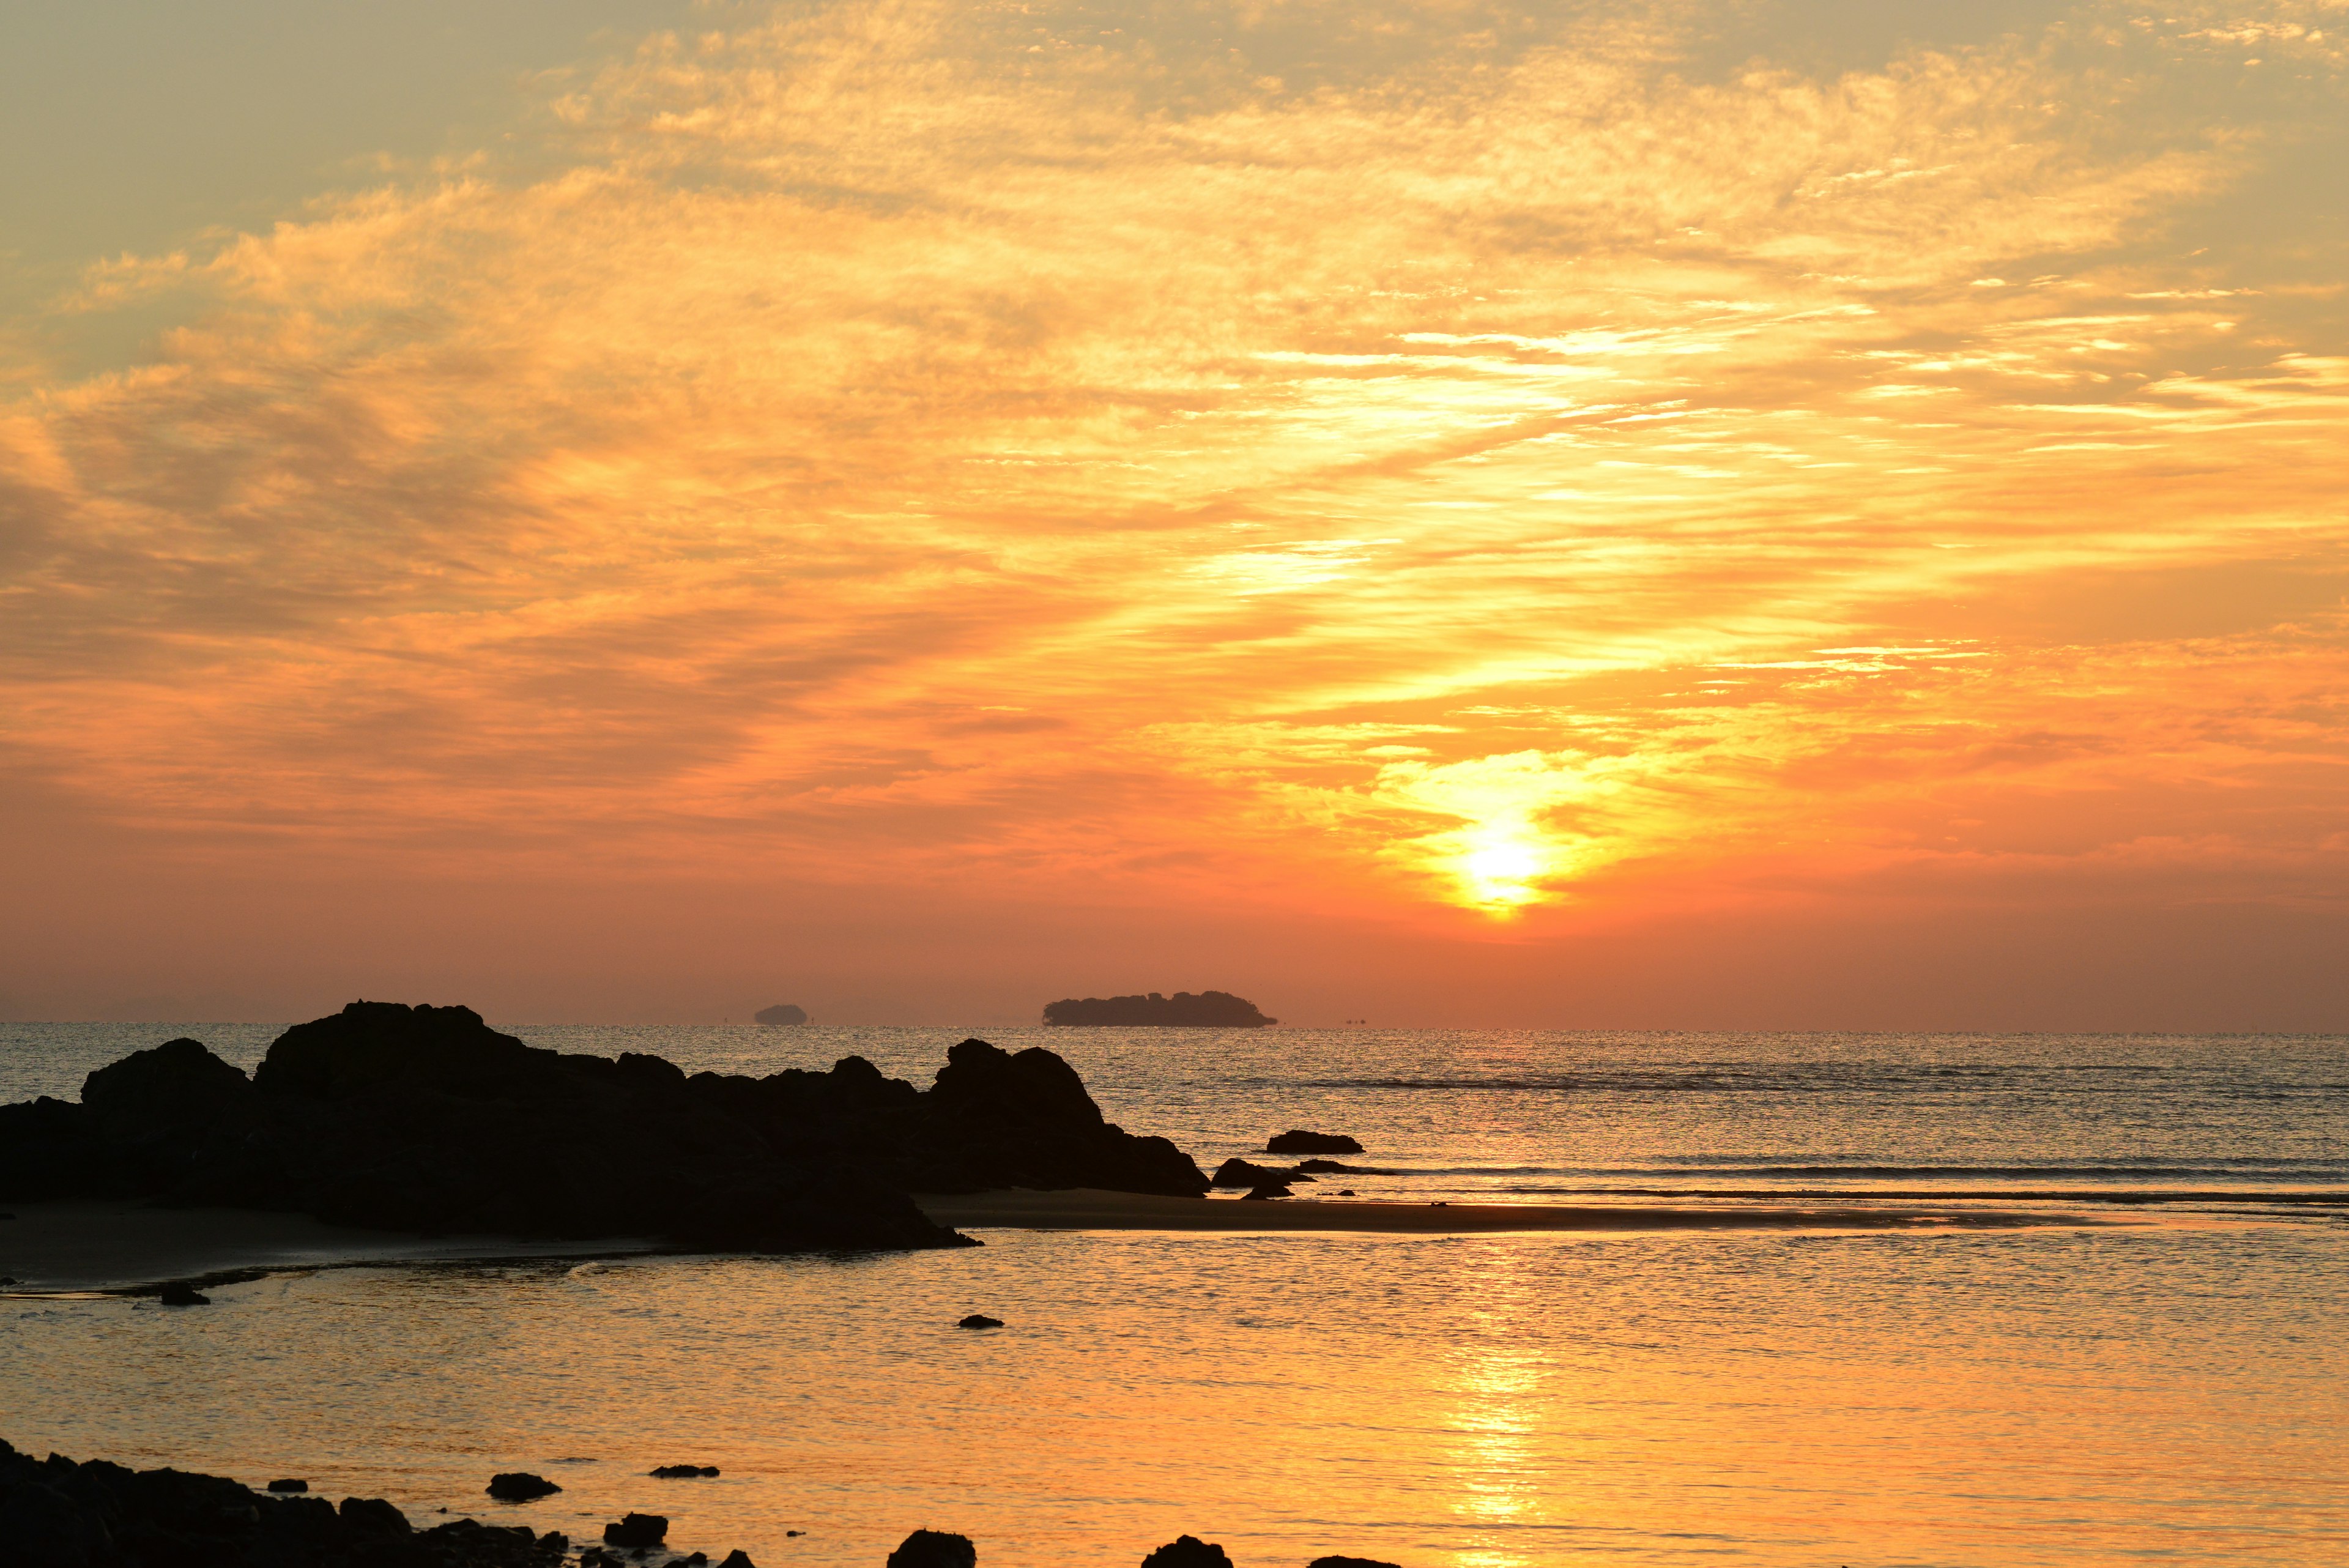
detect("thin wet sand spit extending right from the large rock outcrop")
[914,1187,2109,1234]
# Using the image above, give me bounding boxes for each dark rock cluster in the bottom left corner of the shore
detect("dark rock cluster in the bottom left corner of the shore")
[0,1441,571,1568]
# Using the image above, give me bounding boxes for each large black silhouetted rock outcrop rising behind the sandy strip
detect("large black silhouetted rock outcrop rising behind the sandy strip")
[0,1001,1208,1250]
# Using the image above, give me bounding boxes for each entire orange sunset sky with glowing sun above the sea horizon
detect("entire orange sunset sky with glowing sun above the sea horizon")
[0,0,2349,1030]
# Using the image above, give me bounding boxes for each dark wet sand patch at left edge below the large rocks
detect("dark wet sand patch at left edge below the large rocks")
[0,1202,660,1295]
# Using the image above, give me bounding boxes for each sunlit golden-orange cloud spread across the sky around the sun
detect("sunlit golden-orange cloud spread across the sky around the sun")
[0,0,2349,1025]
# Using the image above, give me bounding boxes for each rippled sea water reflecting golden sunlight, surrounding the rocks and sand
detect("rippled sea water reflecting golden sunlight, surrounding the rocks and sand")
[0,1025,2349,1568]
